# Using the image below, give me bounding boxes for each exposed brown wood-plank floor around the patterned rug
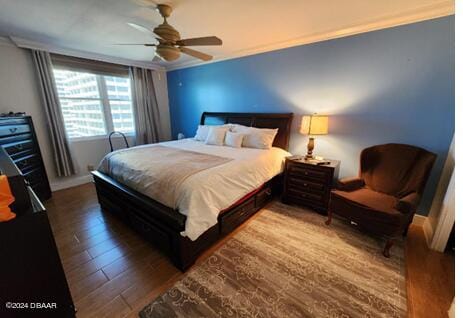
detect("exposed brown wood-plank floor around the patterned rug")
[46,184,454,317]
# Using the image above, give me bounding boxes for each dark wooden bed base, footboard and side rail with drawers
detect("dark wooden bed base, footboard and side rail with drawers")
[92,171,282,271]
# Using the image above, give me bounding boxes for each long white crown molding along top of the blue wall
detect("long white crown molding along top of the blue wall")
[166,0,455,71]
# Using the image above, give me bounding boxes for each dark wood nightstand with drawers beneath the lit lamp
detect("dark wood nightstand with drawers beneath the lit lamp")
[282,156,341,214]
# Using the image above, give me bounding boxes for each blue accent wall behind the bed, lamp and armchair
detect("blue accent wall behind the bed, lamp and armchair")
[167,16,455,215]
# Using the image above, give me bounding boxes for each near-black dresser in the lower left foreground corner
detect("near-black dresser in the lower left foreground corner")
[0,147,75,318]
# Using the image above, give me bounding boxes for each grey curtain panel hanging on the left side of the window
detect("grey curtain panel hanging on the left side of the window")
[32,50,76,177]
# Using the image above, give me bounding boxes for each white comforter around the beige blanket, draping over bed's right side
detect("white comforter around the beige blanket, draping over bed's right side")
[100,139,291,241]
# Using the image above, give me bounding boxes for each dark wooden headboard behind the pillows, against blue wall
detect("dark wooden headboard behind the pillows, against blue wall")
[201,112,293,150]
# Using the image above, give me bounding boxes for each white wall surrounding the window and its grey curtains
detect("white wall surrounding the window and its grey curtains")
[0,37,171,190]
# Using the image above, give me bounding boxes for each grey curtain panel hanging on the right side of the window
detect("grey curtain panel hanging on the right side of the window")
[130,67,161,145]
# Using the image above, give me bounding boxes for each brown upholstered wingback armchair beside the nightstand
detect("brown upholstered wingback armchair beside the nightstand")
[326,144,436,257]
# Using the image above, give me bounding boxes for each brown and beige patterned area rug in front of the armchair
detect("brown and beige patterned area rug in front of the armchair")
[140,202,407,318]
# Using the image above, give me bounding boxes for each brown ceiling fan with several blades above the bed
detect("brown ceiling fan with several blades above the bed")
[118,4,222,62]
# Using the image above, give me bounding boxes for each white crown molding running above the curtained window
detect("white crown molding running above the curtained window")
[9,36,165,72]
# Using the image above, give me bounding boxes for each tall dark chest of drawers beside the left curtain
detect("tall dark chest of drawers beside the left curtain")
[0,116,51,201]
